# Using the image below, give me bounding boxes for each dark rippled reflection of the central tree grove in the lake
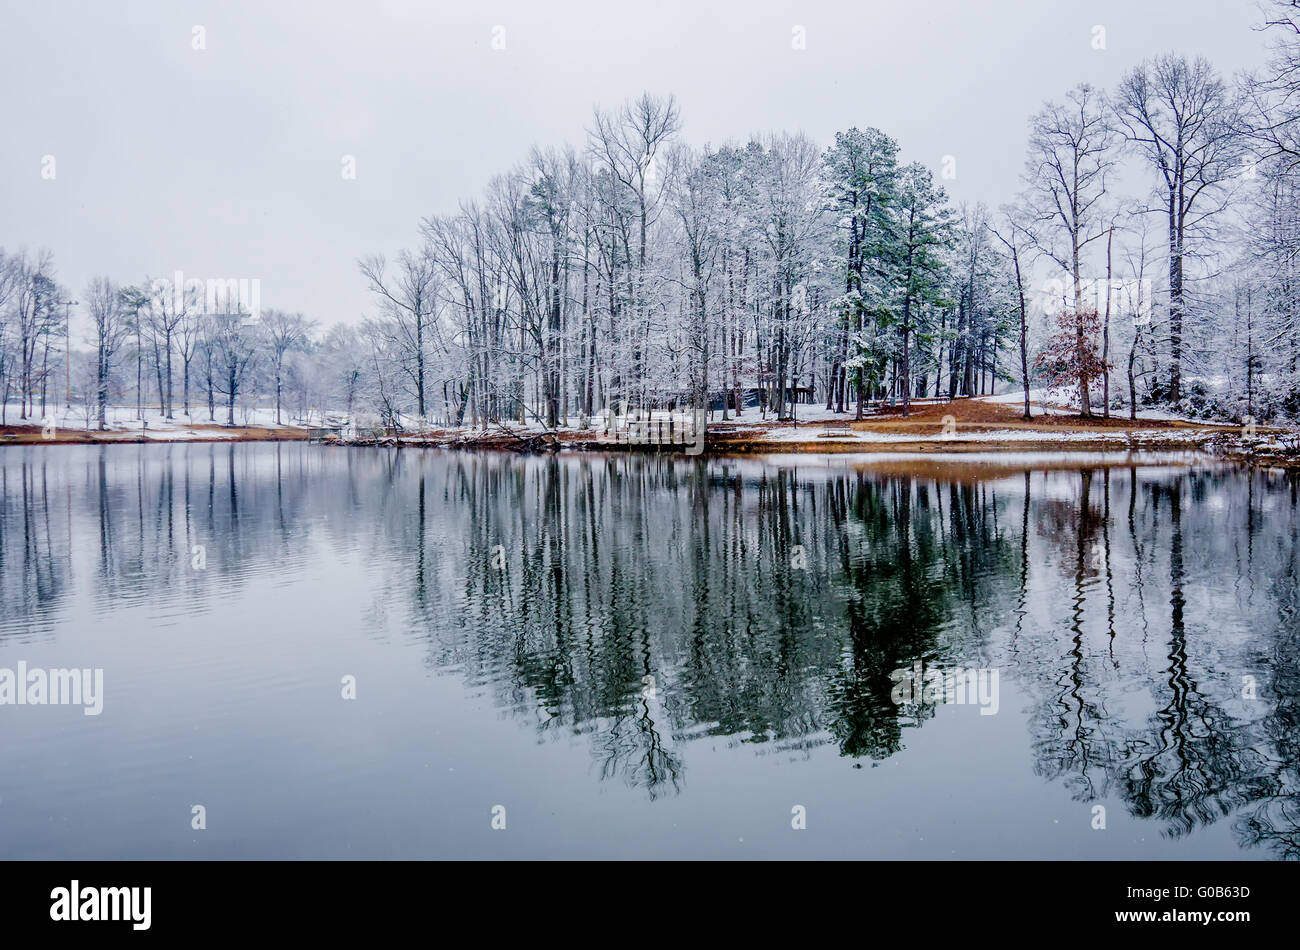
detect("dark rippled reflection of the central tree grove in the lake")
[395,456,1014,791]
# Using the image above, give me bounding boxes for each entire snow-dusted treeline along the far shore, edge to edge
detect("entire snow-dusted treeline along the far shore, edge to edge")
[0,1,1300,428]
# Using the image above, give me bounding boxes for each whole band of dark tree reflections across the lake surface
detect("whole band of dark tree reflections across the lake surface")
[0,446,1300,856]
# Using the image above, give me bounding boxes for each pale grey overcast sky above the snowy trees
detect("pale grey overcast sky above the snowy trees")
[0,0,1265,333]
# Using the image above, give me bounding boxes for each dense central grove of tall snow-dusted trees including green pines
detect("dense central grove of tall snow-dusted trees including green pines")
[361,95,1018,426]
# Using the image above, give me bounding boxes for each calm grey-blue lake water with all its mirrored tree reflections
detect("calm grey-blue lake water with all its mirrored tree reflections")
[0,443,1300,859]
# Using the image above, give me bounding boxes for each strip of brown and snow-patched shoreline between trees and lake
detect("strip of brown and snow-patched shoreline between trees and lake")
[0,398,1300,468]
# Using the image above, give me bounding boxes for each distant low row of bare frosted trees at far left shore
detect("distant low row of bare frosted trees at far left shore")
[0,248,319,429]
